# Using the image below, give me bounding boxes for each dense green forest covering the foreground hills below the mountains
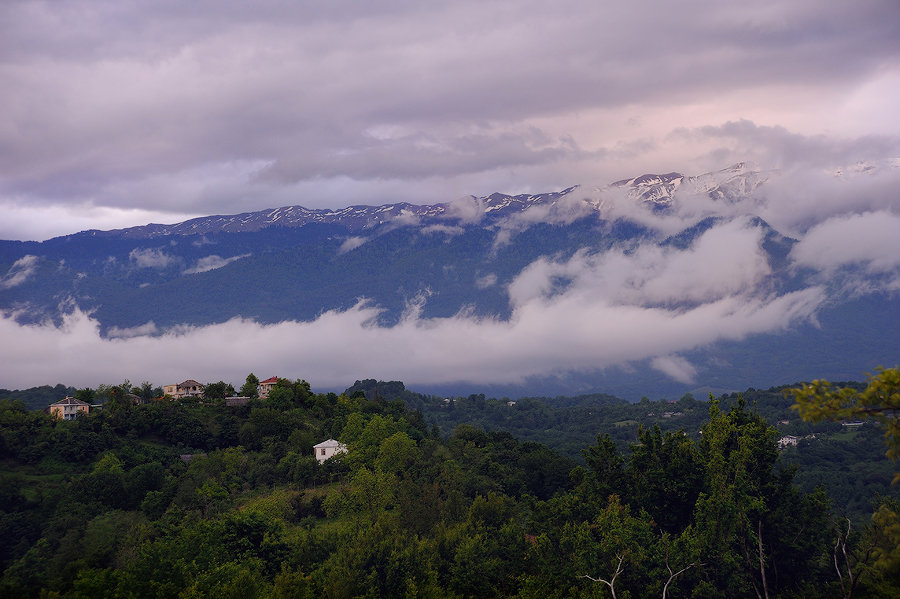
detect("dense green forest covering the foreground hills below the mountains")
[0,373,900,598]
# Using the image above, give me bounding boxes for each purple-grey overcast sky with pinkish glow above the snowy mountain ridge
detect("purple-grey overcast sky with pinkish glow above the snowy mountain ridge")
[0,0,900,239]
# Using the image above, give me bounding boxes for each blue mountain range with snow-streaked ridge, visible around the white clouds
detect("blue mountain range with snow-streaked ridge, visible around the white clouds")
[0,164,900,399]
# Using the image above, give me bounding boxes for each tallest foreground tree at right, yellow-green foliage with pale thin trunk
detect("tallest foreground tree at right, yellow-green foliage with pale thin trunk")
[694,397,829,599]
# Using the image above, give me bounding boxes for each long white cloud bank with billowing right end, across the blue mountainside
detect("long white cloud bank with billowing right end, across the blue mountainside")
[0,216,848,387]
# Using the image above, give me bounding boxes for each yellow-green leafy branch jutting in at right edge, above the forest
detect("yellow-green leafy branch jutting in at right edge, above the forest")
[786,368,900,483]
